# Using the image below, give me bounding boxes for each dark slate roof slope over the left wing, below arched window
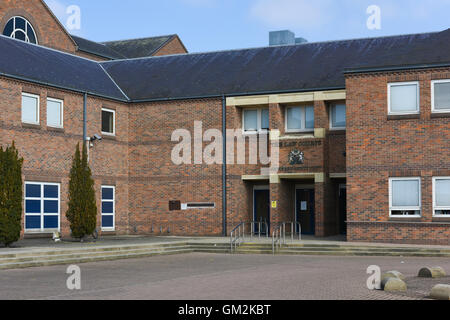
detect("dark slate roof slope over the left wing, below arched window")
[0,36,127,101]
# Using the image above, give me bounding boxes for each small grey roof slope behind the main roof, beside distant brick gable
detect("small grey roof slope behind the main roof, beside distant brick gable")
[102,35,177,58]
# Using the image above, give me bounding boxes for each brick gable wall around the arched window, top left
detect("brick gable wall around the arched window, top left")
[0,0,76,53]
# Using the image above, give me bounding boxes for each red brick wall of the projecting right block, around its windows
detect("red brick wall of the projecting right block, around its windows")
[347,69,450,244]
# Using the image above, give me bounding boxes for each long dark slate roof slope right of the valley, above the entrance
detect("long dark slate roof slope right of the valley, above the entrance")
[101,29,450,101]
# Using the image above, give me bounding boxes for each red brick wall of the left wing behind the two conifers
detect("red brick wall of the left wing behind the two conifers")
[0,78,128,235]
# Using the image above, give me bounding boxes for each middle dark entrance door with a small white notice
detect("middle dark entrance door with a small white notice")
[295,189,316,235]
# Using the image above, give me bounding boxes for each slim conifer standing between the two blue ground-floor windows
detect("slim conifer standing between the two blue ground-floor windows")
[66,144,97,239]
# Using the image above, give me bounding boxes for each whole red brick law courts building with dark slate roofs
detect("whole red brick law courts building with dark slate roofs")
[0,0,450,244]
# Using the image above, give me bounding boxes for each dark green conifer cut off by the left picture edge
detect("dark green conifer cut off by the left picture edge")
[0,142,23,246]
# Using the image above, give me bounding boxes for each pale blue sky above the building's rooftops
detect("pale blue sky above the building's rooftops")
[45,0,450,52]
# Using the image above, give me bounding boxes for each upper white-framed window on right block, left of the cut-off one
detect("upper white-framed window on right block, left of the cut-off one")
[388,82,420,115]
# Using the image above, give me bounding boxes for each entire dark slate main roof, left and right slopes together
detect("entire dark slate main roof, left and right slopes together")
[0,29,450,102]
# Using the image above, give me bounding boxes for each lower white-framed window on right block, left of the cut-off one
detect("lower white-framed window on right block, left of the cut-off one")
[389,178,421,217]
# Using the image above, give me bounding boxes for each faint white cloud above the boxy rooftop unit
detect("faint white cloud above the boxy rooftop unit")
[250,0,333,29]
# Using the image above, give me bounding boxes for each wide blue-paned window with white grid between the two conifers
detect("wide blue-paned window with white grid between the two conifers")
[25,182,60,232]
